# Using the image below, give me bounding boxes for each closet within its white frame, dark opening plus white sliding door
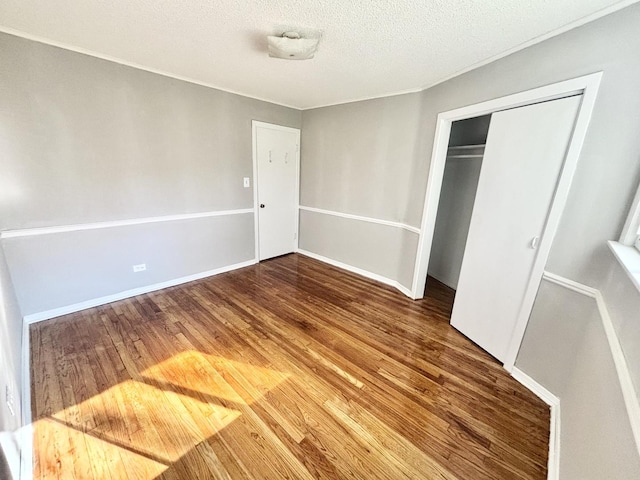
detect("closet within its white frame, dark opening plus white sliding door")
[428,95,581,361]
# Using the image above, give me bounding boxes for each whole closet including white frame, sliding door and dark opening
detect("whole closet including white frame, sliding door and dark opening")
[412,73,601,370]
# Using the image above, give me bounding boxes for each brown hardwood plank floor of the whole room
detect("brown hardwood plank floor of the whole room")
[31,255,549,480]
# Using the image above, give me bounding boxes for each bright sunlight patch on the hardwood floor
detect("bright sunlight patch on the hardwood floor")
[33,351,289,479]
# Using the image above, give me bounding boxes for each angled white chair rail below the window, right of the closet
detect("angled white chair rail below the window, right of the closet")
[542,272,640,456]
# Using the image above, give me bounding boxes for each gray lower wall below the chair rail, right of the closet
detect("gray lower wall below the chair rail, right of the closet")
[516,280,640,480]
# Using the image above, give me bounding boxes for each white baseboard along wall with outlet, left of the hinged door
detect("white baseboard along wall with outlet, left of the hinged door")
[23,258,257,324]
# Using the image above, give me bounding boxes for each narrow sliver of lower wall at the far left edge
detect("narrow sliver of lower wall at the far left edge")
[0,247,22,432]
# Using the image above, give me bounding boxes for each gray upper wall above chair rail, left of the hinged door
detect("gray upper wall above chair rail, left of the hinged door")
[0,34,301,230]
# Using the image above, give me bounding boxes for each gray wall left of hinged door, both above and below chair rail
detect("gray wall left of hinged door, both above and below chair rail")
[0,34,301,315]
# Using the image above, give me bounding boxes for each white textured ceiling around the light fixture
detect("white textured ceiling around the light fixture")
[0,0,635,108]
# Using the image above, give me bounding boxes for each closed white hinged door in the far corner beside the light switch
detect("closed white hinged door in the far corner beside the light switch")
[253,122,300,260]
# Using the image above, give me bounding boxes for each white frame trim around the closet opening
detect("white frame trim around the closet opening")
[411,72,602,371]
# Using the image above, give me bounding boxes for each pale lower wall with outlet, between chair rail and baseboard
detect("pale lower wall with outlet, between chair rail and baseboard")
[2,213,255,316]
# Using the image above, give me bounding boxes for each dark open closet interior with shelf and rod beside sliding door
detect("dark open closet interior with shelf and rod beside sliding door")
[428,115,491,290]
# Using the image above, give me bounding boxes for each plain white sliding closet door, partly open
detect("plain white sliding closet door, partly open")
[451,96,582,361]
